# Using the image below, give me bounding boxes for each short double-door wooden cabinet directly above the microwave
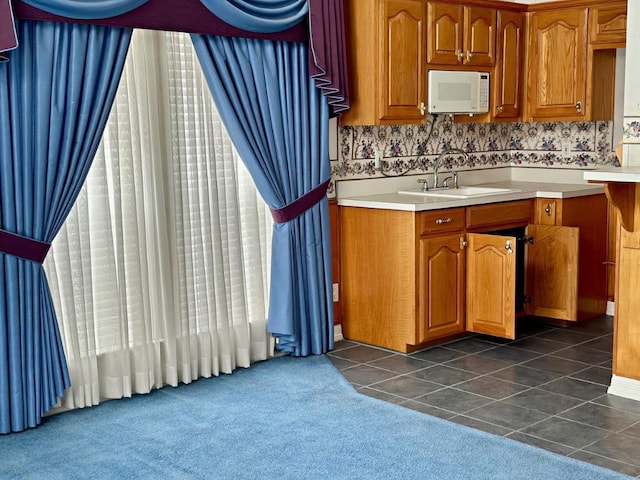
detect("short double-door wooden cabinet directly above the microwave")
[427,2,496,66]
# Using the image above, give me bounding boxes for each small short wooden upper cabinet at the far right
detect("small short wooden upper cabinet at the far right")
[589,2,627,48]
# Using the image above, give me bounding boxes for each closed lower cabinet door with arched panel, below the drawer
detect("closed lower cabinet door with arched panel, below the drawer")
[417,232,465,343]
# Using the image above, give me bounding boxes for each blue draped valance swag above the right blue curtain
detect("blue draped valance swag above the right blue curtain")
[200,0,309,33]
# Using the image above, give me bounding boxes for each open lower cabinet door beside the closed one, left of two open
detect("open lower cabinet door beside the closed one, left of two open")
[467,233,517,339]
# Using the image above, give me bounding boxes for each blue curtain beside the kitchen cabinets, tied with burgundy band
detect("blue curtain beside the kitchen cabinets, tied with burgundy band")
[192,35,333,356]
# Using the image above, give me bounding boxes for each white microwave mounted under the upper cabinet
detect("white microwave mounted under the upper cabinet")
[427,70,489,114]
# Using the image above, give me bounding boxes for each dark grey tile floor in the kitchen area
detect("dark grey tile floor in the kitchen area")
[329,316,640,478]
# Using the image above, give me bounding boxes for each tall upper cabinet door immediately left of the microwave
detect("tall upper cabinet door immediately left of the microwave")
[380,0,427,122]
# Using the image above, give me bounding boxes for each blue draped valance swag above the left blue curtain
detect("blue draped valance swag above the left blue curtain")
[24,0,148,20]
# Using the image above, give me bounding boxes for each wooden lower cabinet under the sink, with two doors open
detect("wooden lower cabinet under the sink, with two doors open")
[340,195,606,352]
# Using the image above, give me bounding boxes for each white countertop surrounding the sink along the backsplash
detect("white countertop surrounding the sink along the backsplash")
[338,179,604,212]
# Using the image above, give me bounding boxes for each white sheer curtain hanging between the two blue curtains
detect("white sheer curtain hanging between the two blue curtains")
[45,31,273,409]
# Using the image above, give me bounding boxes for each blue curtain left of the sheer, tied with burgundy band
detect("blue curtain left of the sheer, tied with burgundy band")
[0,21,131,433]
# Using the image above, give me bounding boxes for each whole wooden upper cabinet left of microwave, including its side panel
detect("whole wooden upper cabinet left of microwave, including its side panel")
[340,0,427,125]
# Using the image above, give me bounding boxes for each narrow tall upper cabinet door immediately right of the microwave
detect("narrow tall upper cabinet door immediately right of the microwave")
[493,10,524,120]
